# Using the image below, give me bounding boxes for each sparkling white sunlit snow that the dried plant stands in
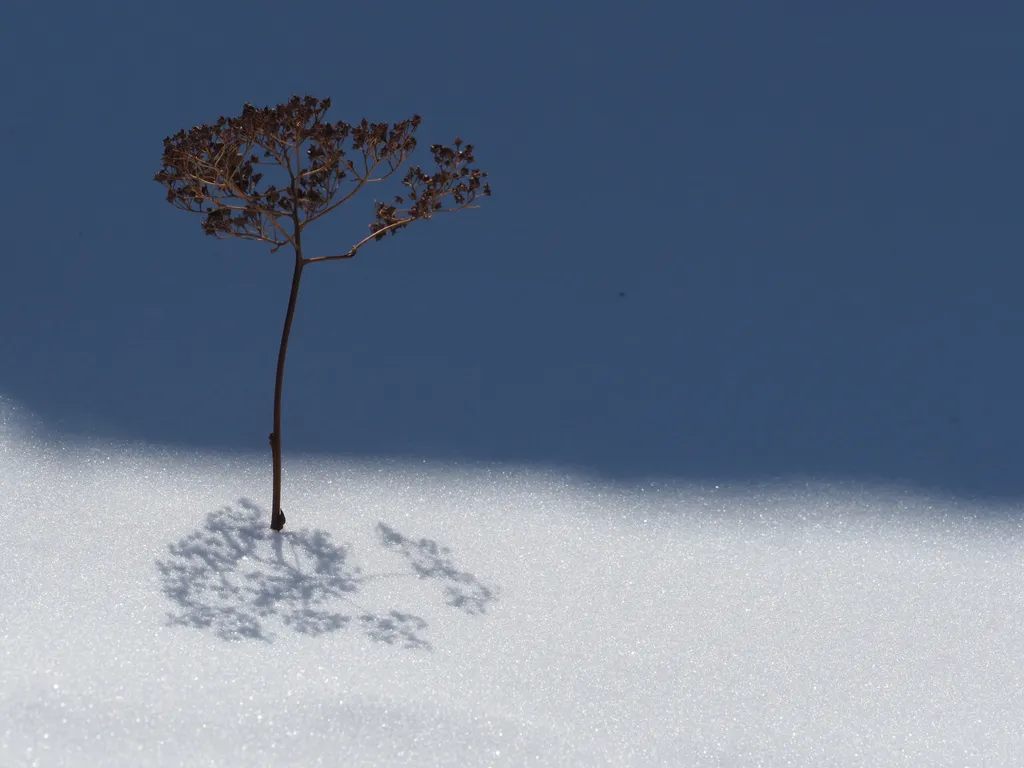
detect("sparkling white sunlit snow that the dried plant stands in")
[0,403,1024,767]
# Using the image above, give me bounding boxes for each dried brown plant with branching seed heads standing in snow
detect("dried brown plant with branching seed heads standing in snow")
[155,96,490,530]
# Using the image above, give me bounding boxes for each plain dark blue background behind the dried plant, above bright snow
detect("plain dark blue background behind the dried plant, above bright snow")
[0,0,1024,498]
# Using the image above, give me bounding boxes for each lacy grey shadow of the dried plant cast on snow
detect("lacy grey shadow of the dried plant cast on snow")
[157,499,495,650]
